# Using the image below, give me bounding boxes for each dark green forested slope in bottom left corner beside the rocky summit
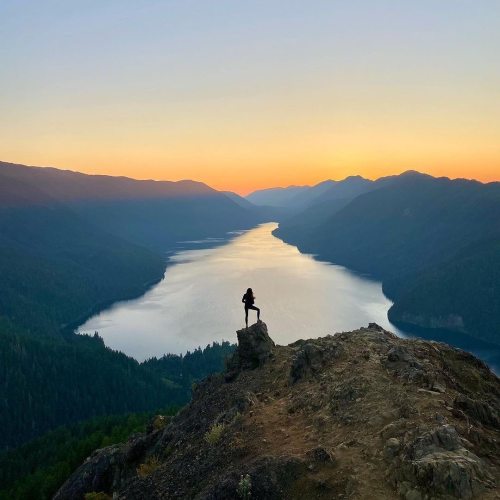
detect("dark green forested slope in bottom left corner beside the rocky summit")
[0,407,177,500]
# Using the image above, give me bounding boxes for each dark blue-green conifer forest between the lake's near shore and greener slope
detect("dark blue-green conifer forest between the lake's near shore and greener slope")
[0,322,233,449]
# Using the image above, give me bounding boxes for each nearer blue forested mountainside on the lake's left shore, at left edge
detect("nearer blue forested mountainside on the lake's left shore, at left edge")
[0,170,165,334]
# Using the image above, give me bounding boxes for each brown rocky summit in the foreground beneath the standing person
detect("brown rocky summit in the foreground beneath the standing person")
[55,322,500,500]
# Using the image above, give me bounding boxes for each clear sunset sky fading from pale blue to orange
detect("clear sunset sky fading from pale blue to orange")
[0,0,500,193]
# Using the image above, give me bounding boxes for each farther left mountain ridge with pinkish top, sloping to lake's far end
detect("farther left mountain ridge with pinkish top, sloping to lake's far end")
[0,162,269,253]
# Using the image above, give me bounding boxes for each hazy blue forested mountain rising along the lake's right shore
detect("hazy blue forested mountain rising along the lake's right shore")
[275,172,500,344]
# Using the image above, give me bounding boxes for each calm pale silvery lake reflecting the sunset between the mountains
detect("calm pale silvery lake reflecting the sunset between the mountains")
[79,223,401,360]
